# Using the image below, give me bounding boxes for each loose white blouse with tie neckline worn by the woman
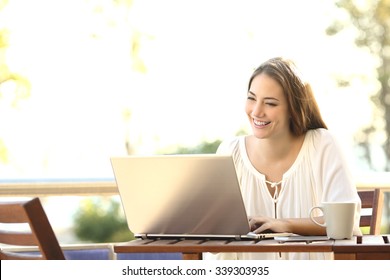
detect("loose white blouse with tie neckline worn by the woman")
[204,129,361,259]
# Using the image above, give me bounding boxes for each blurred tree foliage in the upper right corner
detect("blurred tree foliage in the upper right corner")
[326,0,390,171]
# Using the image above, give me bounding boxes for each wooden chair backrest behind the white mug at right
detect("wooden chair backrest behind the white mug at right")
[358,189,384,235]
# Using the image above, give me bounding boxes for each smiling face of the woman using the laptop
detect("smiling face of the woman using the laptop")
[245,73,291,139]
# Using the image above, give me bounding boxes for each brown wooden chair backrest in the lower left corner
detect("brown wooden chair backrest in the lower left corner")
[0,198,65,260]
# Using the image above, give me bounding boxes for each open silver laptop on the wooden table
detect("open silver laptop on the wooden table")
[111,154,286,240]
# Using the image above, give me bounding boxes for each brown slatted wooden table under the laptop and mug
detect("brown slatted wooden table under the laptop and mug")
[114,235,390,260]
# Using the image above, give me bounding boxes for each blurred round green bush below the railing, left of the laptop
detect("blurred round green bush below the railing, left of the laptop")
[74,198,134,243]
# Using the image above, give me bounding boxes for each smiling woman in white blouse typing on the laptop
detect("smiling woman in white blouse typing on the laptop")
[205,58,360,259]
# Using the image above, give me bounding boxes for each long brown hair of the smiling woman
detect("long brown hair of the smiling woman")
[248,57,327,136]
